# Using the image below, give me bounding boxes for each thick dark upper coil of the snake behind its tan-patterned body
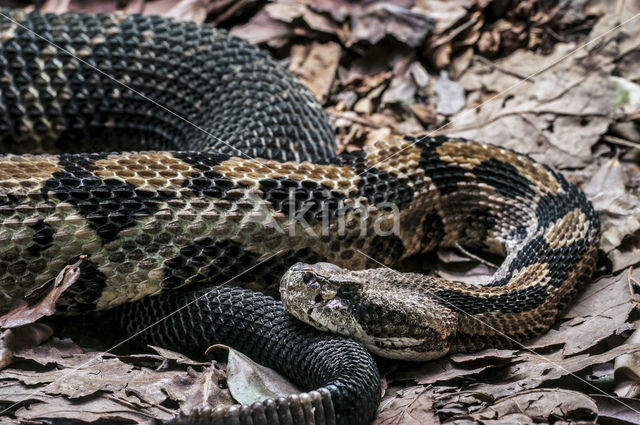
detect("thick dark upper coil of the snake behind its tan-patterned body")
[0,10,335,161]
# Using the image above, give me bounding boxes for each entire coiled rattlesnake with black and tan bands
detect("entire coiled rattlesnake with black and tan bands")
[0,10,600,425]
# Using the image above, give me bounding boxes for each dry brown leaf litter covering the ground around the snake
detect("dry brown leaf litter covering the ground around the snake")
[0,0,640,425]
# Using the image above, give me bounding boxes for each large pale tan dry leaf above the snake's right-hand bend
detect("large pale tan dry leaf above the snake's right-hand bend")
[447,43,614,167]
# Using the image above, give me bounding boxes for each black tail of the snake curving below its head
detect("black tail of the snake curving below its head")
[114,286,381,425]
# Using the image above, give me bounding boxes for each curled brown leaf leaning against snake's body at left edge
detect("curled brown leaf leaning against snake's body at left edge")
[0,255,87,328]
